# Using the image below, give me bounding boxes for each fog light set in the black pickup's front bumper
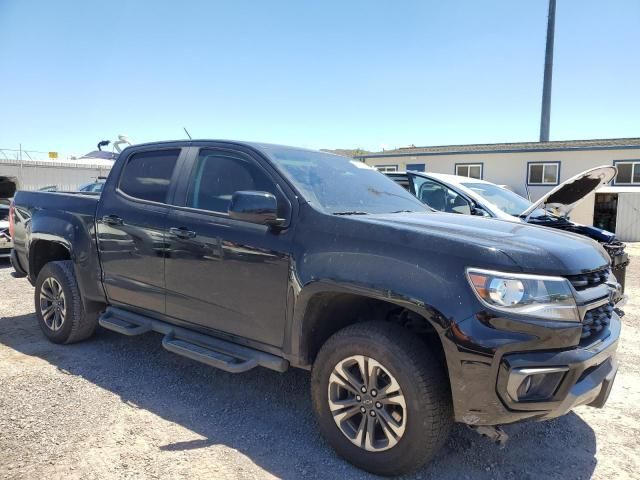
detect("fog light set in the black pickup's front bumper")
[507,367,569,402]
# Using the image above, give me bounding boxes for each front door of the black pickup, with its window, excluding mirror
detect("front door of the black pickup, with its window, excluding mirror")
[165,148,291,347]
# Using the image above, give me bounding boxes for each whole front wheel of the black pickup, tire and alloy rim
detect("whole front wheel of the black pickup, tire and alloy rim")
[311,322,453,475]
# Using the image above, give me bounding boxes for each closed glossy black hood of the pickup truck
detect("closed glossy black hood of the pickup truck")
[351,212,610,275]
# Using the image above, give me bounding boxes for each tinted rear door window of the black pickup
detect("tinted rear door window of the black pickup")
[118,149,180,203]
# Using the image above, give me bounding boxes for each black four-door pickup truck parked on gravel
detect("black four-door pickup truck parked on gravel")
[10,141,621,475]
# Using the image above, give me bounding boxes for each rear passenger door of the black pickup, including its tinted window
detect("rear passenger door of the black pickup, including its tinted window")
[96,146,188,314]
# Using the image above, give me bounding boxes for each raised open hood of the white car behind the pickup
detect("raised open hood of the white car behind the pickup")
[520,165,618,221]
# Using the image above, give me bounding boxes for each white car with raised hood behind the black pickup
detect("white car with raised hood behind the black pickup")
[386,165,629,291]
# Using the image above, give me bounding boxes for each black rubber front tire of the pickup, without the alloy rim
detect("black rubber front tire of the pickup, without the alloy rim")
[311,322,453,476]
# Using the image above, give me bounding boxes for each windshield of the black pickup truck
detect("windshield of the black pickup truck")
[261,145,430,215]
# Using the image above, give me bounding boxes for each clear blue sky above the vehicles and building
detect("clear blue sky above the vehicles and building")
[0,0,640,153]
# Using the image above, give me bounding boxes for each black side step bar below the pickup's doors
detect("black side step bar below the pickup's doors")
[98,307,289,373]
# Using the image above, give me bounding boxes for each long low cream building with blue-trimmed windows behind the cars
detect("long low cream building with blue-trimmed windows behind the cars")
[356,138,640,241]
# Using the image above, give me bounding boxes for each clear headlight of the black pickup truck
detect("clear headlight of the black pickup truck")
[467,268,580,322]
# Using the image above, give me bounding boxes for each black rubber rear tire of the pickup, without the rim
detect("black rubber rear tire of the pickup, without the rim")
[34,260,98,343]
